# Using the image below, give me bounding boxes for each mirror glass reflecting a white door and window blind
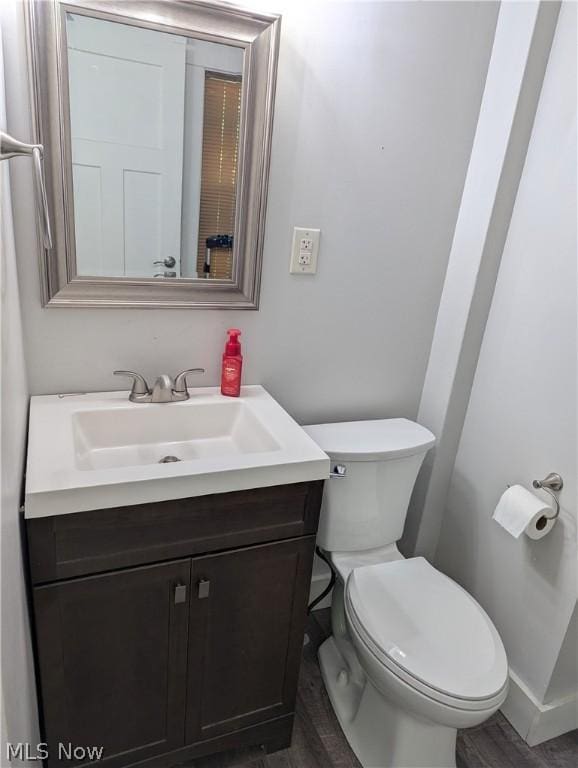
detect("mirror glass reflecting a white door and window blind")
[66,12,244,281]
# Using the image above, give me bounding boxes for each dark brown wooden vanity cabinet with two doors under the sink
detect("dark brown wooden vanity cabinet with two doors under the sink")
[27,481,323,768]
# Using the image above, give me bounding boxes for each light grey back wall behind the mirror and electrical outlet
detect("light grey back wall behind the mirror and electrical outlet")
[3,2,497,422]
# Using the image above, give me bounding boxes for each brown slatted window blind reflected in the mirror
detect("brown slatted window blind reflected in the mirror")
[197,71,241,279]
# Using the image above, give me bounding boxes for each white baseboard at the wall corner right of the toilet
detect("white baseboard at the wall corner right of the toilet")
[501,670,578,747]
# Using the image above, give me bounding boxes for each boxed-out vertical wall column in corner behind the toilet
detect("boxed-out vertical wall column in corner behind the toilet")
[401,2,559,558]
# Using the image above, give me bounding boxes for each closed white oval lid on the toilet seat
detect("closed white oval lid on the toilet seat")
[347,557,508,700]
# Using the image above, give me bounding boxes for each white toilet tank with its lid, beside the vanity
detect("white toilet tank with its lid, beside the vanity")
[304,419,435,552]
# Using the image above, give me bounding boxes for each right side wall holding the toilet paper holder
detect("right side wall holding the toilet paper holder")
[436,3,578,736]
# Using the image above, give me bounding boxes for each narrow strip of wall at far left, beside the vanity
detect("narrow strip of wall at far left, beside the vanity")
[0,12,38,765]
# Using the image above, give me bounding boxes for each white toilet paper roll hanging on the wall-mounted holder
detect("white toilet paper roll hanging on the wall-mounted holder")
[492,485,556,539]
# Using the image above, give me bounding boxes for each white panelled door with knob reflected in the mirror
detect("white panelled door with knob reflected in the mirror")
[66,14,186,277]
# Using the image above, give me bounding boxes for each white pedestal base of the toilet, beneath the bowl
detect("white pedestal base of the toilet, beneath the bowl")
[319,637,457,768]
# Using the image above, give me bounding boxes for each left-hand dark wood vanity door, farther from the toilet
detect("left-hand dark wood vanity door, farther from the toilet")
[34,560,191,768]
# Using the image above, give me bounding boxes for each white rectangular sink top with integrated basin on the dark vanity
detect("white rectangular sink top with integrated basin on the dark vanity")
[25,386,329,518]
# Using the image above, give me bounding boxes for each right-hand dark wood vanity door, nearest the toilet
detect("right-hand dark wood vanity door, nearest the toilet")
[186,536,315,743]
